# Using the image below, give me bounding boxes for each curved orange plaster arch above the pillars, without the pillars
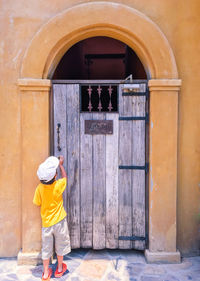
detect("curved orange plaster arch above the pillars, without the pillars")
[20,2,178,79]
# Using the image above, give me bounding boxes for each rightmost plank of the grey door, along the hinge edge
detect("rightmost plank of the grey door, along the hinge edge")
[132,97,146,250]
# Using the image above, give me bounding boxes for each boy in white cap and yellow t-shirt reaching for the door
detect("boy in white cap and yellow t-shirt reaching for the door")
[33,156,71,280]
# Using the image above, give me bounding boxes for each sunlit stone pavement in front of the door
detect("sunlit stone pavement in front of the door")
[0,249,200,281]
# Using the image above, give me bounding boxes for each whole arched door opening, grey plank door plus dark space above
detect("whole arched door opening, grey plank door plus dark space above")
[52,37,148,250]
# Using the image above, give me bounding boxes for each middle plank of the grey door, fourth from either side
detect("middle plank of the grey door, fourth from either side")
[93,113,106,249]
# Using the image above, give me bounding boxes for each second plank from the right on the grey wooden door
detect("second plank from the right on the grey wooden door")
[118,85,132,249]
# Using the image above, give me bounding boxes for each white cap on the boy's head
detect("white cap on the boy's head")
[37,156,59,182]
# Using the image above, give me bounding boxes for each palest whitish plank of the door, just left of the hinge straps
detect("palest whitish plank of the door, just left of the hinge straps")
[106,113,119,249]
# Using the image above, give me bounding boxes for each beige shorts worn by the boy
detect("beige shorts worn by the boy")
[42,218,71,260]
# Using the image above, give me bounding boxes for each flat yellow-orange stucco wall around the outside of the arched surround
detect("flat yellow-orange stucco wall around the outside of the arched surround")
[0,0,200,256]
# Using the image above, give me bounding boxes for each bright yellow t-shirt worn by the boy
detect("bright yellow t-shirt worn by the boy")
[33,178,67,227]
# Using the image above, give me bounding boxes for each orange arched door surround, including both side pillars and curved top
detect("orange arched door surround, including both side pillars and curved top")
[18,2,181,262]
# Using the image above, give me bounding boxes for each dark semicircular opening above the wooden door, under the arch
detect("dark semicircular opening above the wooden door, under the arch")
[52,36,147,80]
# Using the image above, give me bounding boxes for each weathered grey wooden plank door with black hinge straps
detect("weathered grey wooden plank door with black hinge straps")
[53,83,146,249]
